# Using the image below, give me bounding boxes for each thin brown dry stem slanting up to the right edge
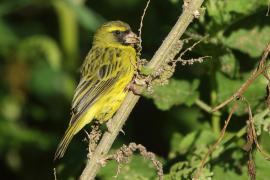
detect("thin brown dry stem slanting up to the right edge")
[212,43,270,111]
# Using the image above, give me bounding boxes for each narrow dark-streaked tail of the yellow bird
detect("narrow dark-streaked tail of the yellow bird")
[54,123,78,161]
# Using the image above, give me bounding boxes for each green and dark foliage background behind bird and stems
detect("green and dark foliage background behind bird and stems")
[0,0,270,180]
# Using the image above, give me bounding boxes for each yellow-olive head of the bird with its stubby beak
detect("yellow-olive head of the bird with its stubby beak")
[93,21,139,46]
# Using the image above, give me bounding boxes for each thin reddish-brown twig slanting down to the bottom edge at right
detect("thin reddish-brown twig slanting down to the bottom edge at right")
[194,102,238,180]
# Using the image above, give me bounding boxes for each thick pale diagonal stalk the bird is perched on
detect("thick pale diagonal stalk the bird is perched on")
[80,0,204,180]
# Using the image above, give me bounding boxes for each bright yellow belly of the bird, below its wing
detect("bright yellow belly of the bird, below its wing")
[95,74,132,122]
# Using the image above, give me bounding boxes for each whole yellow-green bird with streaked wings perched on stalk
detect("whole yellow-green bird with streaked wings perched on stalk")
[55,21,139,159]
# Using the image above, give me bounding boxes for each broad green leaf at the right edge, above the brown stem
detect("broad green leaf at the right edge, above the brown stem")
[223,26,270,58]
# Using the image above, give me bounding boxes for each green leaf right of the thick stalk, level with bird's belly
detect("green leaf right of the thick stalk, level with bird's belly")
[146,79,199,110]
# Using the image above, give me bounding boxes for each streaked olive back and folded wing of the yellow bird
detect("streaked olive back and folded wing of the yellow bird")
[70,48,123,125]
